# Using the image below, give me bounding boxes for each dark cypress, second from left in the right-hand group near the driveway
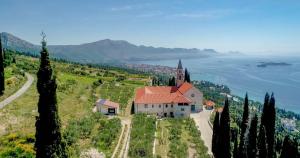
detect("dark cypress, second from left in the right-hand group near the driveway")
[218,97,231,158]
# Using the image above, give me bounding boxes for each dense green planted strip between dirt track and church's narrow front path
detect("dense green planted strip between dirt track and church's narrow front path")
[129,114,156,158]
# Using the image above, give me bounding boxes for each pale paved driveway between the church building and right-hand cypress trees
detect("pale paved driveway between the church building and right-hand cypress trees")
[191,109,213,155]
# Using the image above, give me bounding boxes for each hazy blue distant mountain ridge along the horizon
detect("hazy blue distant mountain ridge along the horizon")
[1,32,219,63]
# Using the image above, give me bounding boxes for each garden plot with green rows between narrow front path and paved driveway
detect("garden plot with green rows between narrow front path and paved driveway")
[156,118,209,158]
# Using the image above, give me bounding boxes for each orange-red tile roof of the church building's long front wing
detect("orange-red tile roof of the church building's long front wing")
[135,86,191,104]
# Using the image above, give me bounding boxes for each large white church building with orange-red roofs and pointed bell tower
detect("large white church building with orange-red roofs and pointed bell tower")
[134,60,203,117]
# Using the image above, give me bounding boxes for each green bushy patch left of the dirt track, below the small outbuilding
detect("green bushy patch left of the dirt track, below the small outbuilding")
[63,113,121,157]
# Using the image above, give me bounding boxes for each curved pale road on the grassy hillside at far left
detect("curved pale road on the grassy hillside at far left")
[0,73,34,109]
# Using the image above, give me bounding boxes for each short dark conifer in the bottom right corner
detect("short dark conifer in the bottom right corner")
[280,136,298,158]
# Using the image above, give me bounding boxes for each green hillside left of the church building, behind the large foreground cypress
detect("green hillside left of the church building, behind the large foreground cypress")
[0,55,148,158]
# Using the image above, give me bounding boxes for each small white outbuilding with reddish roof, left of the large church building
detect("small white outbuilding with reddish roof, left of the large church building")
[96,99,120,115]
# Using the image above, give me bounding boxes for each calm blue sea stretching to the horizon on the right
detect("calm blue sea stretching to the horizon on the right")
[135,57,300,113]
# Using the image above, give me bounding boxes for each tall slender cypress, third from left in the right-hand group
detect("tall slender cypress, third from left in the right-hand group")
[238,93,249,157]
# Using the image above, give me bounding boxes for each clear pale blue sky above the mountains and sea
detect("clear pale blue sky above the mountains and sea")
[0,0,300,54]
